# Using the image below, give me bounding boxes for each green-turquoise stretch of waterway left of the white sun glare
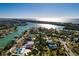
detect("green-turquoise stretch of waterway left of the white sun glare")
[0,23,35,49]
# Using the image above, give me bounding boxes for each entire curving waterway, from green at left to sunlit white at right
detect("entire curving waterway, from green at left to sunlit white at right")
[0,22,63,49]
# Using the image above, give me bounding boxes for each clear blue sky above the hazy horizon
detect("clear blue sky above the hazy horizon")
[0,3,79,18]
